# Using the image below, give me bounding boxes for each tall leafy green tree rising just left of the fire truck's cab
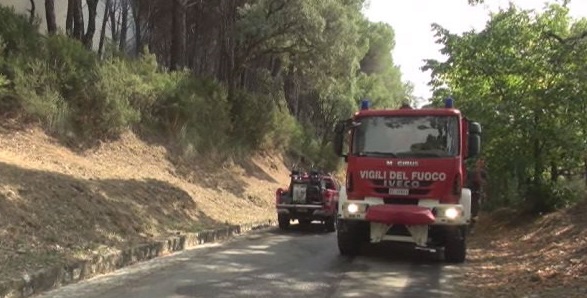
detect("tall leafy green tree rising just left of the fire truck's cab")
[235,0,409,169]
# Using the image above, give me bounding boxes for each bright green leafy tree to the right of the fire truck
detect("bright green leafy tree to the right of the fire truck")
[425,1,587,212]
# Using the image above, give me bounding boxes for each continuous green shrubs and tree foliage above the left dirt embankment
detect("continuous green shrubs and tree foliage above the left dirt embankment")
[0,0,410,170]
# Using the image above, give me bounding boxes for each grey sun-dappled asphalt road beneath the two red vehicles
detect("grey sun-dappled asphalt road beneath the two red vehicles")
[35,225,461,298]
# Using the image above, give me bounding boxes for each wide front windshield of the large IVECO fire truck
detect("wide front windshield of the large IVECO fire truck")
[352,116,459,157]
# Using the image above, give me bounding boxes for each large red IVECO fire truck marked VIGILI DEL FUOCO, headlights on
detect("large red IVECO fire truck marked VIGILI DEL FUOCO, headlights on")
[334,98,481,263]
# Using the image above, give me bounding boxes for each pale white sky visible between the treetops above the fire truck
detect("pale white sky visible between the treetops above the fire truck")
[365,0,587,103]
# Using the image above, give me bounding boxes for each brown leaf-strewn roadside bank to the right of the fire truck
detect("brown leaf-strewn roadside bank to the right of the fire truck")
[462,202,587,298]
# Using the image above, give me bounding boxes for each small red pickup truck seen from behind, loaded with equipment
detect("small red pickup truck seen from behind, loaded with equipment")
[275,170,340,232]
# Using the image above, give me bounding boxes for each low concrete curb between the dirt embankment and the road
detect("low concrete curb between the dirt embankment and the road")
[0,220,276,298]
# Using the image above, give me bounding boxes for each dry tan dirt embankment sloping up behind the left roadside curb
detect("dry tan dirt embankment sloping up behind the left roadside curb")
[0,126,289,281]
